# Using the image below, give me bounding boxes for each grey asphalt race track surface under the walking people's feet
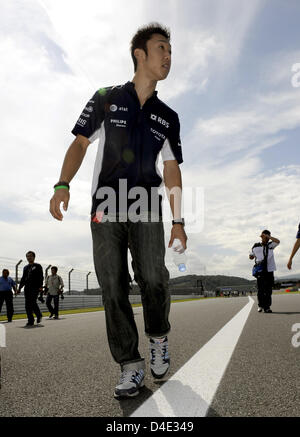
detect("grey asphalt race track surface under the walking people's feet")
[0,294,300,417]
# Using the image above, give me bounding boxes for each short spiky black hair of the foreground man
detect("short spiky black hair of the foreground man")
[130,23,170,72]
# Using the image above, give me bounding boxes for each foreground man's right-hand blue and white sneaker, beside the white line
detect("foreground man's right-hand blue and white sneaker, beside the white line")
[150,337,170,379]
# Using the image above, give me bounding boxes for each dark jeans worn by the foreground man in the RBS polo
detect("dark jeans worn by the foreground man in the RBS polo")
[91,221,170,364]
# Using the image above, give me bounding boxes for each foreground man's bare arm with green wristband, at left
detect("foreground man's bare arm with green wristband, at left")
[50,134,90,220]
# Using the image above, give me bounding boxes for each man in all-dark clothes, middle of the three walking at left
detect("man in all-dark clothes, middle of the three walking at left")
[18,250,44,328]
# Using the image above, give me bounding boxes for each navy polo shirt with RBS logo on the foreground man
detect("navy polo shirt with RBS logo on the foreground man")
[72,82,183,214]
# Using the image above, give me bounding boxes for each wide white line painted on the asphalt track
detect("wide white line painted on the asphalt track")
[131,297,254,417]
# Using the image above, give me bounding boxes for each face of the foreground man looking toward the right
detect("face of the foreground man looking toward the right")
[139,33,171,81]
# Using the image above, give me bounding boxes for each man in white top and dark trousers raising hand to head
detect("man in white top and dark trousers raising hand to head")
[249,229,280,313]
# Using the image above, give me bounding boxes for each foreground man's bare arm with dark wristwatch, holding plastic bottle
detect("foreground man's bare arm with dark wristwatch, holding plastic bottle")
[164,160,187,249]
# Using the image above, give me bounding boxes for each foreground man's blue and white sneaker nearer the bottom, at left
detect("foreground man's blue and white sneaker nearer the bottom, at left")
[114,361,145,399]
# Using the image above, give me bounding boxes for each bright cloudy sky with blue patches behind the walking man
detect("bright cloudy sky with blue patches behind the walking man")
[0,0,300,279]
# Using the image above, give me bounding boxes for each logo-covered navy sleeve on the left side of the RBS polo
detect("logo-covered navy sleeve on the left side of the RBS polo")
[72,88,107,143]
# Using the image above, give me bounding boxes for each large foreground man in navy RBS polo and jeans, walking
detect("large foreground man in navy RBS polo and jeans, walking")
[50,23,187,398]
